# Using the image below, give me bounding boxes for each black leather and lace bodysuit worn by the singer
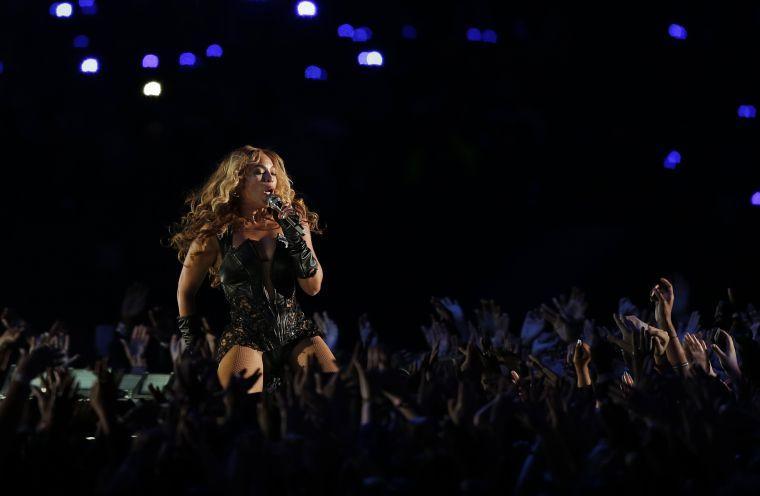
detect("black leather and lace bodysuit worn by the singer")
[216,228,323,361]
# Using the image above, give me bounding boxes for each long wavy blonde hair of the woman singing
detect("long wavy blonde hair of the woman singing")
[169,145,322,287]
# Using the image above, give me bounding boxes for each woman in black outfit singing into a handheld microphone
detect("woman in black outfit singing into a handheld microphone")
[171,146,338,393]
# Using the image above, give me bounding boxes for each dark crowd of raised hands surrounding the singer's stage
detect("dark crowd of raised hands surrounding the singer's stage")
[0,278,760,495]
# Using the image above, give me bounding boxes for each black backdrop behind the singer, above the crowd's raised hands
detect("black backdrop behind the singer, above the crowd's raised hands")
[0,0,760,354]
